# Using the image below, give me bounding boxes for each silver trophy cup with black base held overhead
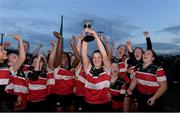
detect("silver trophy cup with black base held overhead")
[83,19,94,42]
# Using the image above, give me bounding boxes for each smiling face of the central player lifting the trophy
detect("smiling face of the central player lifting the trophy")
[92,52,102,68]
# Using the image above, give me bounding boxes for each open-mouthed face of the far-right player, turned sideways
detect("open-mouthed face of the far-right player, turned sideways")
[143,50,155,63]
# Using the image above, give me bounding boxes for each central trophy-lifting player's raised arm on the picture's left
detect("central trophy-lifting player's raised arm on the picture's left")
[81,41,90,70]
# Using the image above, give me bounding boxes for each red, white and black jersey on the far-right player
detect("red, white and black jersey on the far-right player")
[135,64,166,94]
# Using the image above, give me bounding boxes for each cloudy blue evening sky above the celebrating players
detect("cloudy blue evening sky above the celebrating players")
[0,0,180,51]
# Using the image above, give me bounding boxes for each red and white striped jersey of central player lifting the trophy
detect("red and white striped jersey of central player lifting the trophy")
[85,65,111,104]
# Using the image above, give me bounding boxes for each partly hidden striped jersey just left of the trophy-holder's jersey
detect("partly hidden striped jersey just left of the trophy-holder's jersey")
[74,65,86,96]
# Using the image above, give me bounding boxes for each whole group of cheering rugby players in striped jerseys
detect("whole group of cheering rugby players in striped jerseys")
[0,28,167,112]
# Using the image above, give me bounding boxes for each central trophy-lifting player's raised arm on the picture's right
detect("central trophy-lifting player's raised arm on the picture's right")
[85,28,111,69]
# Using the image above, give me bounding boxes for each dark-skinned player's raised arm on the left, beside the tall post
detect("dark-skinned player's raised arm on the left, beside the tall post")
[53,31,63,68]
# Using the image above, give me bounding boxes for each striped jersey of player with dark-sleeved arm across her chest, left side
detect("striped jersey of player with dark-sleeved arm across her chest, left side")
[28,76,47,102]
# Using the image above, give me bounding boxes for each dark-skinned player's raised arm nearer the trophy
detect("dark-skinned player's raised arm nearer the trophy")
[70,35,80,68]
